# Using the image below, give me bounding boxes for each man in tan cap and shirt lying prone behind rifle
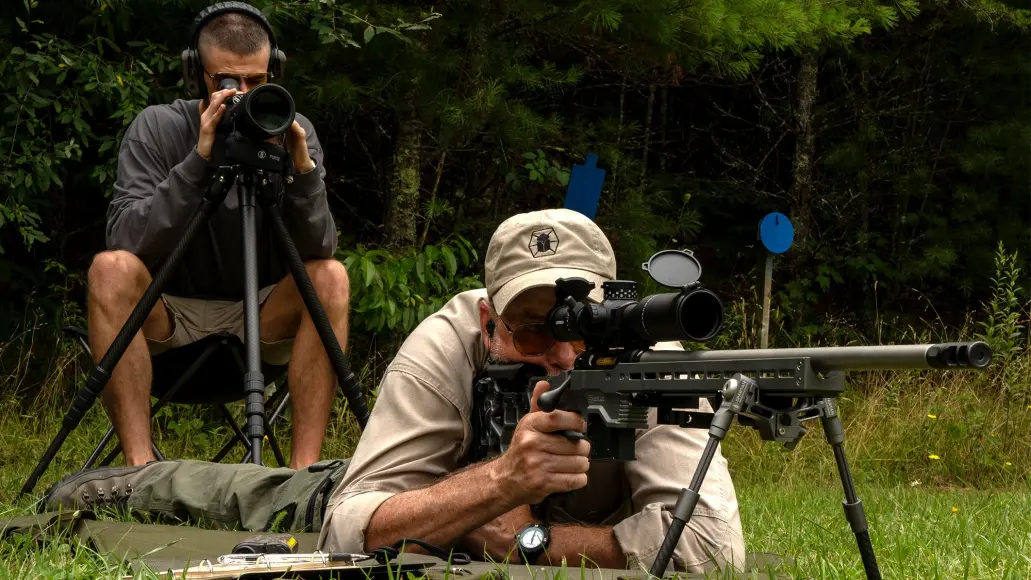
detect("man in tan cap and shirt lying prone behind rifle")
[46,209,745,572]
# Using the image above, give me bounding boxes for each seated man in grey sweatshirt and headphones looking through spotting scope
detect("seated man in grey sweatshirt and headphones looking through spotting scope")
[88,6,348,469]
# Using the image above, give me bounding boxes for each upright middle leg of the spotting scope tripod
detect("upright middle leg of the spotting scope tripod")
[238,172,268,466]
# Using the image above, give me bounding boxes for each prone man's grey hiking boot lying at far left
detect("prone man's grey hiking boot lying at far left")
[43,462,157,510]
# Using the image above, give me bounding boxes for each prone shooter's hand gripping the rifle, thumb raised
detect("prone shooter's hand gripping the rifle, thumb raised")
[492,381,591,506]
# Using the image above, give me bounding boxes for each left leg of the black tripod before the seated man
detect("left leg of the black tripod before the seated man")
[18,168,234,498]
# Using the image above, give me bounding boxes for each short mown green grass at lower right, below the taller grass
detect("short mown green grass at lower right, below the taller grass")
[738,484,1031,580]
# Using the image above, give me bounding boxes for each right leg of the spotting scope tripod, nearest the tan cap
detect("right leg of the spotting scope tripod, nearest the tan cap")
[261,175,369,430]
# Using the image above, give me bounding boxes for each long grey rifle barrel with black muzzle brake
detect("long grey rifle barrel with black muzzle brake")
[640,341,992,372]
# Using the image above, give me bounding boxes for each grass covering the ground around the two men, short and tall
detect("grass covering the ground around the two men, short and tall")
[0,284,1031,580]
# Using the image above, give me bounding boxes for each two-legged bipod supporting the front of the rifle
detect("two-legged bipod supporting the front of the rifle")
[648,373,880,580]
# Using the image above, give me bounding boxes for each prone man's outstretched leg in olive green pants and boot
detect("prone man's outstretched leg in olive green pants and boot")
[44,459,350,533]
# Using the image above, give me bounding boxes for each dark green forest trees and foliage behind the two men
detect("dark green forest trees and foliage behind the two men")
[0,0,1031,358]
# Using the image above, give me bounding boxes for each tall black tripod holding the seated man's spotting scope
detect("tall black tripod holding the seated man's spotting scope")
[19,133,369,497]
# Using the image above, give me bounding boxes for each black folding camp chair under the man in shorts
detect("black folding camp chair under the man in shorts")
[64,327,290,471]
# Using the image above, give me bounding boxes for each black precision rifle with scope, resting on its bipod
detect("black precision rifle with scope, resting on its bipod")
[471,250,992,579]
